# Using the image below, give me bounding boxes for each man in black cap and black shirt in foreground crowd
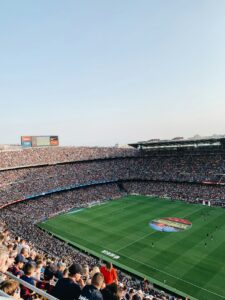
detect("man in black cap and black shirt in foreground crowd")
[51,263,84,300]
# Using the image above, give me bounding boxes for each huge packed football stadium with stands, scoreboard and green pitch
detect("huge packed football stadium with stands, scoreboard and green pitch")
[0,136,225,300]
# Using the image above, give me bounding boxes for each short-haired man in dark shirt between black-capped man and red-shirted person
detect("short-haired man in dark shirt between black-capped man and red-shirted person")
[79,273,104,300]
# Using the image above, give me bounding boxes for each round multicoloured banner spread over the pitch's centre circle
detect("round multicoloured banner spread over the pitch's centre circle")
[149,218,192,232]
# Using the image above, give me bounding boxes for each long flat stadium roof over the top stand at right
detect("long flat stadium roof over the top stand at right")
[129,137,225,150]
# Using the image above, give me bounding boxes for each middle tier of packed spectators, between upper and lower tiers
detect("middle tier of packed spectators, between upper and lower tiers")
[0,148,225,206]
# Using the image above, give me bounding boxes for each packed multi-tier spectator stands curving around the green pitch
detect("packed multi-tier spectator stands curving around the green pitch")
[0,143,225,300]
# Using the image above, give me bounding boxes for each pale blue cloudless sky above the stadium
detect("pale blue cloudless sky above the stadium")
[0,0,225,146]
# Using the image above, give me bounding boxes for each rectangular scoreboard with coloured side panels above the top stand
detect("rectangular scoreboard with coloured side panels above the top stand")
[21,135,59,148]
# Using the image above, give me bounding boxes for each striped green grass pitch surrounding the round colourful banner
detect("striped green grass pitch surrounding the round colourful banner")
[39,196,225,300]
